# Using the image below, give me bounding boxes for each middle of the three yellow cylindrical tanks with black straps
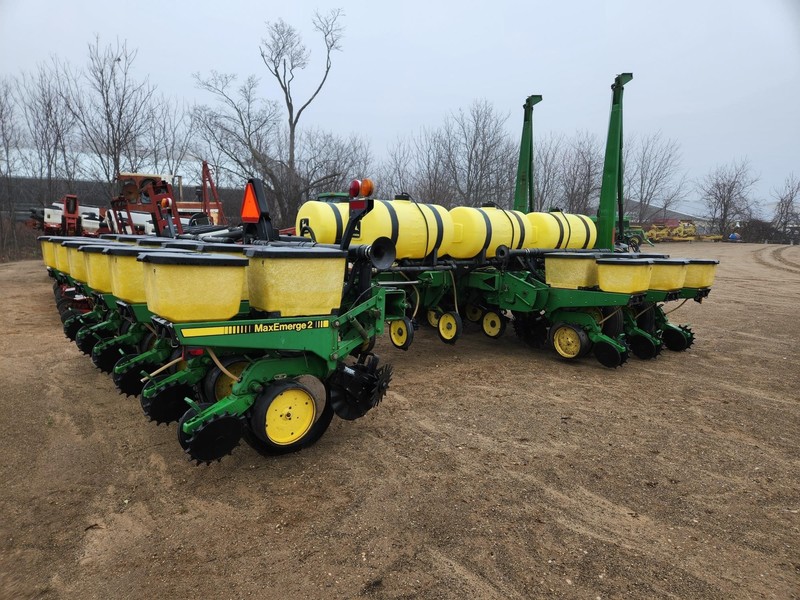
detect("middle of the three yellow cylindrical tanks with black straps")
[447,206,531,259]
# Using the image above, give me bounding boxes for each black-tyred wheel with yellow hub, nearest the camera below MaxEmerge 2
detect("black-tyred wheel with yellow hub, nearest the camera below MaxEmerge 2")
[244,379,333,456]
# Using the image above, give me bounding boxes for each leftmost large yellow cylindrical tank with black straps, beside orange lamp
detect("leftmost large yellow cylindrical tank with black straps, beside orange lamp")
[354,198,453,259]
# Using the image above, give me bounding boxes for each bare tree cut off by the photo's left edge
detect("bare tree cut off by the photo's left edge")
[0,79,22,258]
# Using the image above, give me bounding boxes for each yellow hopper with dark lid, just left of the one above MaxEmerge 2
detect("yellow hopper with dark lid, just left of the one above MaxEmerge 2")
[137,250,247,323]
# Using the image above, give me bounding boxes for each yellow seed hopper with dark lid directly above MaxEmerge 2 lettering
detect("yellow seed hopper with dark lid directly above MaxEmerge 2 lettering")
[245,246,347,317]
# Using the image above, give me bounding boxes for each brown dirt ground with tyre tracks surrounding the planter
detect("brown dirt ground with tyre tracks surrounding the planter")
[0,243,800,600]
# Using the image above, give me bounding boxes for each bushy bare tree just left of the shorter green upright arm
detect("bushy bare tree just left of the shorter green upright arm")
[441,100,518,208]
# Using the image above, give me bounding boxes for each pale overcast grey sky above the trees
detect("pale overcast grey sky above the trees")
[0,0,800,216]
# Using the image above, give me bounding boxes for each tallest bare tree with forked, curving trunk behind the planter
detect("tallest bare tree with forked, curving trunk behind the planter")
[260,9,344,203]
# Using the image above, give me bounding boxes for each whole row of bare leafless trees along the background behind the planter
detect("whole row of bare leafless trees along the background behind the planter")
[0,9,800,258]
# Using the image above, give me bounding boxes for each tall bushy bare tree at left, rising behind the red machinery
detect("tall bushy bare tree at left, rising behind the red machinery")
[64,37,154,196]
